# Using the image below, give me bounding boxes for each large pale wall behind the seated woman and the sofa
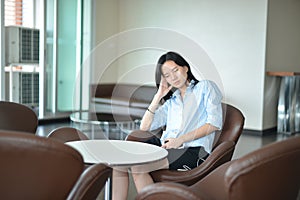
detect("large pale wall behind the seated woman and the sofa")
[92,0,300,130]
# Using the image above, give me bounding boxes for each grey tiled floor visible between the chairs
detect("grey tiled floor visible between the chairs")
[37,121,299,200]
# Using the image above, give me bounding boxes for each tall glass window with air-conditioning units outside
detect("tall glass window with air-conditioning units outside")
[0,0,93,118]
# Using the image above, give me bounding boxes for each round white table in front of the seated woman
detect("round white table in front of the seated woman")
[66,140,168,199]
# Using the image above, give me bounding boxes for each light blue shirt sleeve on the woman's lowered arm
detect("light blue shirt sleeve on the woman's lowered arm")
[204,81,223,129]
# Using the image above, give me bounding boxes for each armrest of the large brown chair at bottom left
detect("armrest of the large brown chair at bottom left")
[67,164,112,200]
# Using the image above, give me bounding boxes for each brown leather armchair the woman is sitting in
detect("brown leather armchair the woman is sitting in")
[127,103,245,185]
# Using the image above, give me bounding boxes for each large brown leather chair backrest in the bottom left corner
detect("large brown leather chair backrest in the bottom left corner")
[0,131,84,200]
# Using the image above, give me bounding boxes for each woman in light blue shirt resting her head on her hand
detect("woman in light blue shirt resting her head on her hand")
[113,52,222,199]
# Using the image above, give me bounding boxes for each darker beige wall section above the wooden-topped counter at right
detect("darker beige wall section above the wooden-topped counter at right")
[266,0,300,71]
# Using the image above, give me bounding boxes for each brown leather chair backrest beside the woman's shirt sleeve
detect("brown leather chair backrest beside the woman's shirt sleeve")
[214,103,245,148]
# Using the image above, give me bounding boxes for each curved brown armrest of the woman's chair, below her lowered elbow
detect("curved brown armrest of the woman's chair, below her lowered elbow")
[150,141,235,186]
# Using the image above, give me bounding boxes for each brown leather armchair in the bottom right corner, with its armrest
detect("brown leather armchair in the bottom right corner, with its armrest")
[136,136,300,200]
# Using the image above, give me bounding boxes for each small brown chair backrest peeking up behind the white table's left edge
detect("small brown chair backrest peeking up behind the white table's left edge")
[48,127,89,143]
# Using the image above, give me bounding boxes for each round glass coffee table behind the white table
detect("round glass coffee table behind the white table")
[70,111,141,140]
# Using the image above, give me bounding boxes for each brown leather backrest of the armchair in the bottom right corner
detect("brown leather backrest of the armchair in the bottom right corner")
[225,137,300,200]
